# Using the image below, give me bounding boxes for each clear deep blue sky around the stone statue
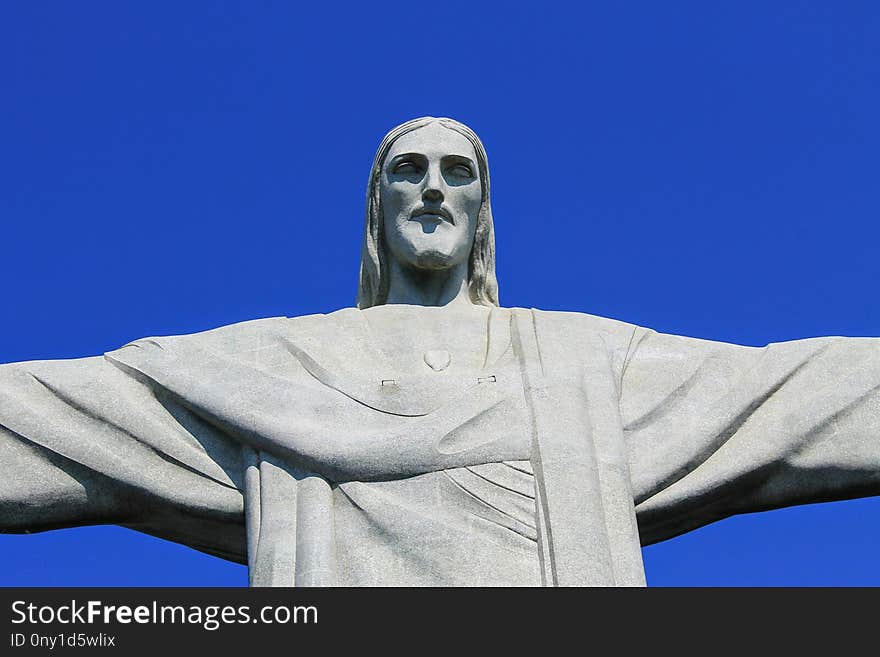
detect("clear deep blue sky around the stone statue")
[0,1,880,585]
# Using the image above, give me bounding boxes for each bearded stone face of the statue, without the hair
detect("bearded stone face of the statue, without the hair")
[380,123,482,270]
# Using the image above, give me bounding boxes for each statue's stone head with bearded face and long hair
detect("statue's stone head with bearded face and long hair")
[357,116,498,309]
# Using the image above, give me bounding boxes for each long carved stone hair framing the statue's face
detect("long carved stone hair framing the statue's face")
[357,116,498,310]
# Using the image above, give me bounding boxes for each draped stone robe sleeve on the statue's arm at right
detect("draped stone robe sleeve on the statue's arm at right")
[620,329,880,545]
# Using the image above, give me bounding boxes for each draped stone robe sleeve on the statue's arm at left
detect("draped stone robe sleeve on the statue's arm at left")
[0,357,245,562]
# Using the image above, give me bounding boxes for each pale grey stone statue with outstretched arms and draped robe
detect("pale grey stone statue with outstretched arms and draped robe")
[0,117,880,586]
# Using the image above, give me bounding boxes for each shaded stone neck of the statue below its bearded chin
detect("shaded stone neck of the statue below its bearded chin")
[385,261,472,306]
